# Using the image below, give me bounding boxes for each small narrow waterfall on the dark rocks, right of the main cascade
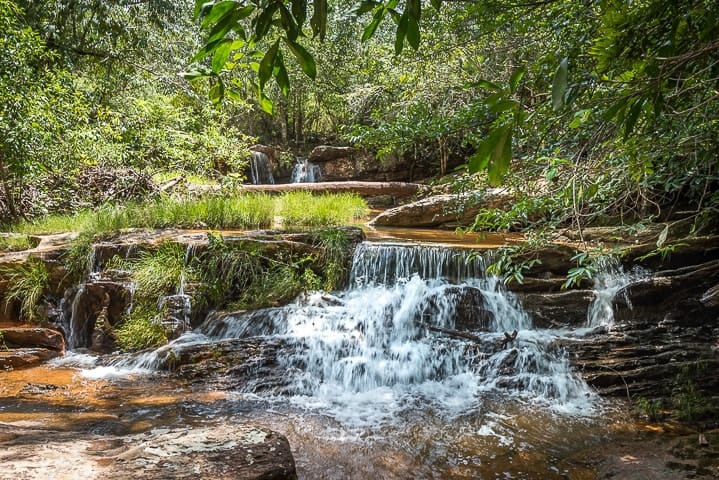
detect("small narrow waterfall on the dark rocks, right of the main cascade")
[587,257,648,328]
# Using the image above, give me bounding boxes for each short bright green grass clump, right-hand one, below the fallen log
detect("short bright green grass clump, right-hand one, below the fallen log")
[276,192,369,227]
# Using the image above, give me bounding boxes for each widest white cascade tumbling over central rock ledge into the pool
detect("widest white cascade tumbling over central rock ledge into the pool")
[84,243,593,424]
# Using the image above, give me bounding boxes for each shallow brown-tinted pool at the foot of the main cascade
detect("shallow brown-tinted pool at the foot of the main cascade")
[0,366,660,480]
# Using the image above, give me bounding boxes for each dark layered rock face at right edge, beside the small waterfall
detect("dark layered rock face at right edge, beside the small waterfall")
[565,260,719,398]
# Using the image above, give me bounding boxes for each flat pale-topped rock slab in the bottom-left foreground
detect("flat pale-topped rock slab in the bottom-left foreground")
[0,424,297,480]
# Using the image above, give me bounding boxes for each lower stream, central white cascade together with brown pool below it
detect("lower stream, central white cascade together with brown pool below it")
[0,240,684,479]
